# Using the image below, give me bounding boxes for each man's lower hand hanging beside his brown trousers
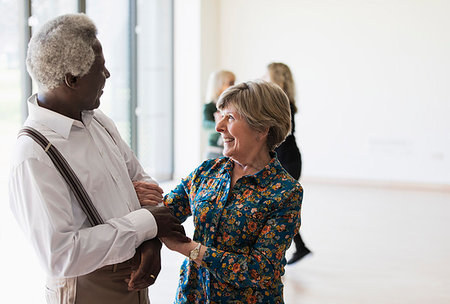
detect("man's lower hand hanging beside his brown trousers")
[125,238,162,291]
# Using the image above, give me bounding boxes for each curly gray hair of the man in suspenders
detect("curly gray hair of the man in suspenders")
[26,14,97,91]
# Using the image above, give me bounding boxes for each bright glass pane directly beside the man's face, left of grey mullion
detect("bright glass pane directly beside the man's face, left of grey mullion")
[86,0,131,144]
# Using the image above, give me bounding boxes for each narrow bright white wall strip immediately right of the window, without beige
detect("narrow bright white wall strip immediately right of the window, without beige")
[174,0,201,180]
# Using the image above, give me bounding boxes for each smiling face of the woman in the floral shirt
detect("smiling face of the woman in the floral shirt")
[216,105,266,162]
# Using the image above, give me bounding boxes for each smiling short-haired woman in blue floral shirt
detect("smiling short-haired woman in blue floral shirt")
[150,81,303,304]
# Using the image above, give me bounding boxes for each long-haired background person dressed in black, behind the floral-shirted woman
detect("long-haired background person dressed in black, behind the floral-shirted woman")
[264,62,311,264]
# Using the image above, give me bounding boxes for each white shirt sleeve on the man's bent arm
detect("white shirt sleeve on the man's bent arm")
[9,158,156,277]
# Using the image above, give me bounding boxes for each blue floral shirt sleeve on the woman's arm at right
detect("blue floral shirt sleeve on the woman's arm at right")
[202,191,302,288]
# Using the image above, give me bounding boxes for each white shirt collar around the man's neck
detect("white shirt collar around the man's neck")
[28,94,94,139]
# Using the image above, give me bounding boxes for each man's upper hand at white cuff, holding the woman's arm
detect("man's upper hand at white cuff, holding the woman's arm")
[144,206,191,243]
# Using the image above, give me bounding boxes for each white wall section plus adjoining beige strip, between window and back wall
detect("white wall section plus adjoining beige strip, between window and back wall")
[174,0,221,181]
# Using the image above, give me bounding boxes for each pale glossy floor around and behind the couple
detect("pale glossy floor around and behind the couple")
[0,178,450,304]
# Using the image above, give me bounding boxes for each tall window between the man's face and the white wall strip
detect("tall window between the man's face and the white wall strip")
[86,0,173,181]
